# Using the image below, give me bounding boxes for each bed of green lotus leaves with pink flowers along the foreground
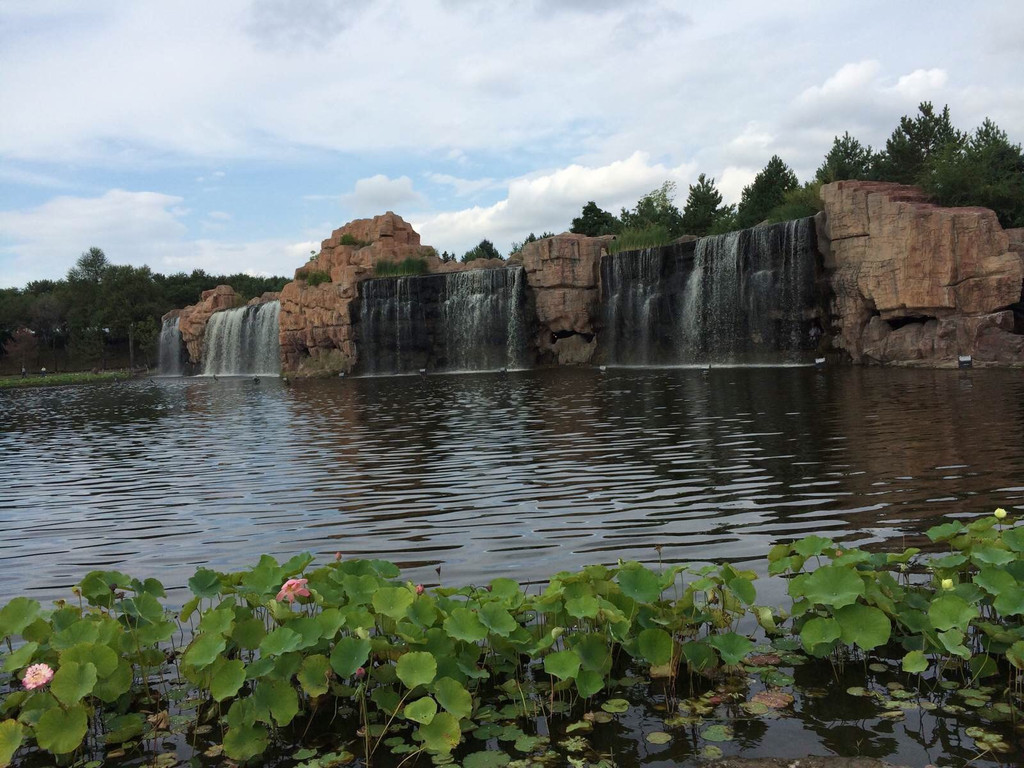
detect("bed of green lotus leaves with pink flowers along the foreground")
[0,510,1024,768]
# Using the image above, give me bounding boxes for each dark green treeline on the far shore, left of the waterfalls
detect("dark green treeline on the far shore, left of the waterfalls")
[0,248,289,374]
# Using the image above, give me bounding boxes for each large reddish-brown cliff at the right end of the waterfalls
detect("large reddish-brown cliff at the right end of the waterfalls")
[819,181,1024,366]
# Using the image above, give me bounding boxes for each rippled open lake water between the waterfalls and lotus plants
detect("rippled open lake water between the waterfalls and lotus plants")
[0,369,1024,600]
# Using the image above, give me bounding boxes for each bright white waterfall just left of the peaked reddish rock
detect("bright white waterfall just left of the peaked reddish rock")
[203,301,281,376]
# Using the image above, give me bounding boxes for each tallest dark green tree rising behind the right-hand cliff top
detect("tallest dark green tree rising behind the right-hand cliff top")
[871,101,967,184]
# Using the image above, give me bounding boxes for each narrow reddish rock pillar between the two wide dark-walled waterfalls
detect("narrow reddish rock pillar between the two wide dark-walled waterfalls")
[522,232,611,366]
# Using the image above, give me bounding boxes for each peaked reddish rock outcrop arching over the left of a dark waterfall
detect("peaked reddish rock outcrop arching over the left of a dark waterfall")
[281,211,441,373]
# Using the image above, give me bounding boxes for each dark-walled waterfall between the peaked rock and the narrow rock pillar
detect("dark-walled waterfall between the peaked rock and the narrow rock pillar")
[357,266,528,374]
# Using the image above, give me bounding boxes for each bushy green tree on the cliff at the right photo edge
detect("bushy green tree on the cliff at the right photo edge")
[921,118,1024,227]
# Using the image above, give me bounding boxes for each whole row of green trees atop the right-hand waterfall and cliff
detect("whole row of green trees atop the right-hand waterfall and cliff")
[569,101,1024,247]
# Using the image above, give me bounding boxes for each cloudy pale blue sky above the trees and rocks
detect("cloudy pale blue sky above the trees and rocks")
[0,0,1024,287]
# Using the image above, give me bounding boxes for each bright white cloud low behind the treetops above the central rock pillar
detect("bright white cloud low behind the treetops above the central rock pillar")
[414,152,696,252]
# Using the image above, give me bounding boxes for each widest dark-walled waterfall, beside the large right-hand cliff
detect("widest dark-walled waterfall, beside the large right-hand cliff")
[601,218,822,366]
